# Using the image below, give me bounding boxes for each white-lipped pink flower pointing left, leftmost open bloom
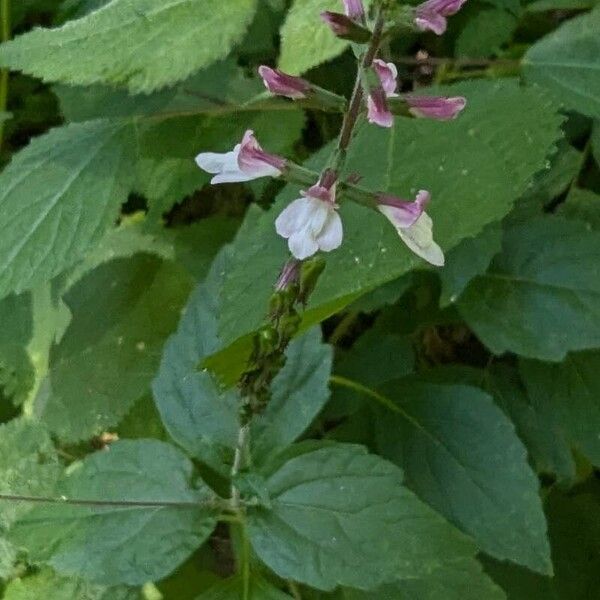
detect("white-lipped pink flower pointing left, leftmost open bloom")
[196,129,286,185]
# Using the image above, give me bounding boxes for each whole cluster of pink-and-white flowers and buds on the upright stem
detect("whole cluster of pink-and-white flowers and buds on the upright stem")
[196,0,466,266]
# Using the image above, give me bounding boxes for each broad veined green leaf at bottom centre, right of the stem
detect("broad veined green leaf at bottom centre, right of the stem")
[248,445,474,590]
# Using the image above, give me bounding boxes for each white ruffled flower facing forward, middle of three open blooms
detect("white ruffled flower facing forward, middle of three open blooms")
[275,182,343,260]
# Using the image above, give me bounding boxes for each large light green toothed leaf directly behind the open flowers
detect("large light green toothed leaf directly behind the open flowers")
[219,81,562,366]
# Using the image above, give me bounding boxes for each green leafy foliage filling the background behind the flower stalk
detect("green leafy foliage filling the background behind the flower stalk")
[0,0,600,600]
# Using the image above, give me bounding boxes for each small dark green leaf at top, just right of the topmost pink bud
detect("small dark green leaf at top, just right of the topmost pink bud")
[455,8,518,58]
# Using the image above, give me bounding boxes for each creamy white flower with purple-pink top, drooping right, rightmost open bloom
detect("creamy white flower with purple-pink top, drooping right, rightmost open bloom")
[377,190,444,267]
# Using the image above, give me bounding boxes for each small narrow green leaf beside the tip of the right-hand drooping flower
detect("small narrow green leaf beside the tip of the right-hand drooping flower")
[439,223,502,307]
